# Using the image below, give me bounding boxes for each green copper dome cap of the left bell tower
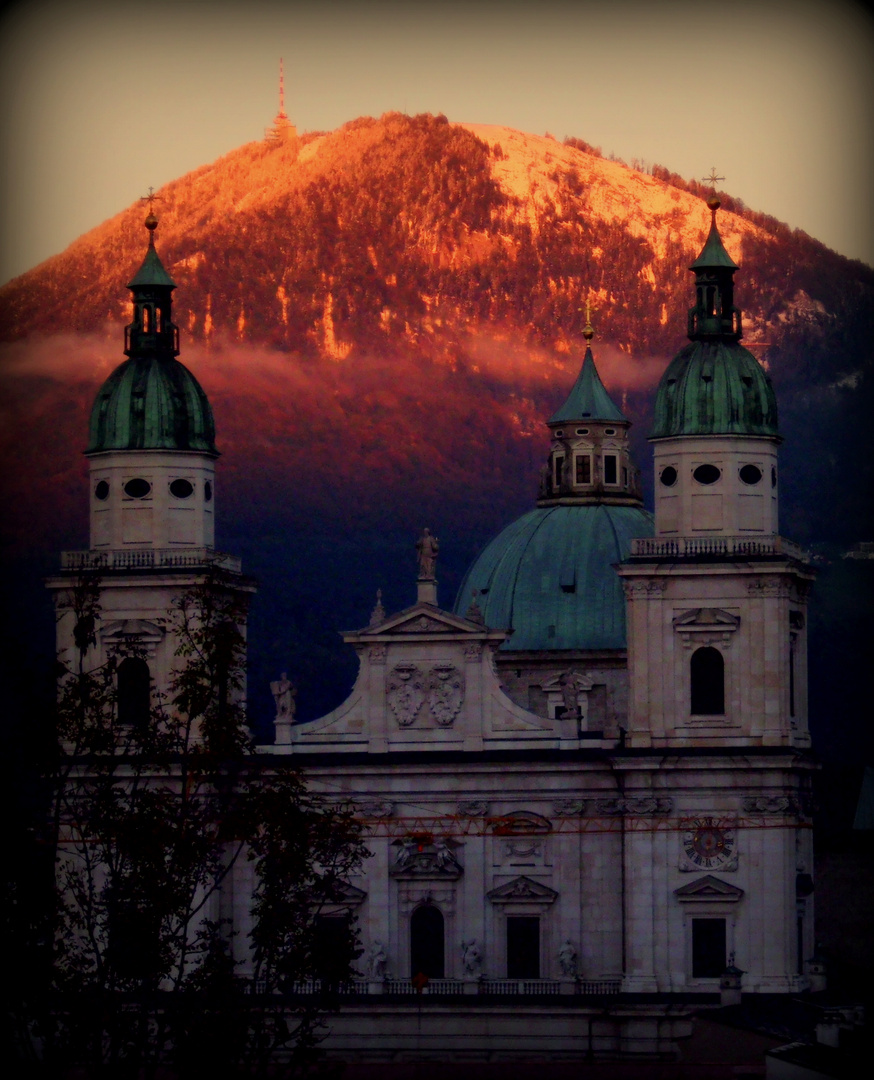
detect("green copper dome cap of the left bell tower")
[85,356,217,454]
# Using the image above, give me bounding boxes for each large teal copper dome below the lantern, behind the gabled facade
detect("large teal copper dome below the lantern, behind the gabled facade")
[455,505,653,651]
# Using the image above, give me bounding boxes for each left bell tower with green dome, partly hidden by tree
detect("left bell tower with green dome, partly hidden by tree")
[48,210,254,716]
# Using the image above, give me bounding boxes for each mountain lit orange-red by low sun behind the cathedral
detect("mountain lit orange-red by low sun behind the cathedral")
[0,113,874,734]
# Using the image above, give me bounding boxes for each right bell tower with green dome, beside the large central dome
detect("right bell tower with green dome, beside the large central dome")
[619,199,814,747]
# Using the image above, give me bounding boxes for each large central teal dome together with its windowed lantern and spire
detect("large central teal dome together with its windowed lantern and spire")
[455,318,653,656]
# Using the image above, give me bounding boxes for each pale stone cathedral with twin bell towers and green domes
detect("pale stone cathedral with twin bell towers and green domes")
[49,192,815,1061]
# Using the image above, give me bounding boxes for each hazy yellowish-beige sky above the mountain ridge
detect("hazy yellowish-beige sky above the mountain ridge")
[0,0,874,283]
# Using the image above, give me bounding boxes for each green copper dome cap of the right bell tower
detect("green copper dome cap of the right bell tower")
[649,340,778,438]
